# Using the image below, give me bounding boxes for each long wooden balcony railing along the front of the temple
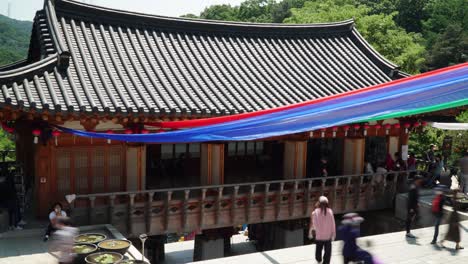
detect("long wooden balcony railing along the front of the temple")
[67,171,410,236]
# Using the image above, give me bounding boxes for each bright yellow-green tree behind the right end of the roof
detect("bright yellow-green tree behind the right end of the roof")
[285,0,425,73]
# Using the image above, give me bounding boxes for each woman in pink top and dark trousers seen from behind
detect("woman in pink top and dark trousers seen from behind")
[309,196,336,264]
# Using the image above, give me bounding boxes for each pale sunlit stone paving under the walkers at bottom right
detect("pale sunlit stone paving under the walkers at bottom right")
[197,221,468,264]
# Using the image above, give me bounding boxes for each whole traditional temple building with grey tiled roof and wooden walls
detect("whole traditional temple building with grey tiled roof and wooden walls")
[0,0,459,258]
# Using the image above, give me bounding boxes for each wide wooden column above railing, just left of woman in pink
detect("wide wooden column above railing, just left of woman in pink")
[283,141,307,179]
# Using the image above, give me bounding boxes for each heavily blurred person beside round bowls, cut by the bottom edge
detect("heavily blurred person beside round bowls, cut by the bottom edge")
[49,216,78,264]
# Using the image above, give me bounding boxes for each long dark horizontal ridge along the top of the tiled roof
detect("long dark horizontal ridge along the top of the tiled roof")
[54,0,354,33]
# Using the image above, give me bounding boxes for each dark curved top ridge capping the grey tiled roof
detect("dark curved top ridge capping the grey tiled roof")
[54,0,354,35]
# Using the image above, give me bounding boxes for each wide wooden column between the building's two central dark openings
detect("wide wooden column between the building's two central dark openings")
[200,143,224,185]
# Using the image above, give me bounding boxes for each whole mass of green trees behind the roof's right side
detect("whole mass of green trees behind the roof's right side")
[187,0,468,74]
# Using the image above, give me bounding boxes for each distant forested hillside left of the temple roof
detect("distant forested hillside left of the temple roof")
[0,15,32,65]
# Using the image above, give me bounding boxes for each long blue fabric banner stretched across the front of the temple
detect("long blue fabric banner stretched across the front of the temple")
[59,65,468,143]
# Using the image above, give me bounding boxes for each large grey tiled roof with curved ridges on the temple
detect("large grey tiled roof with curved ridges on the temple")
[0,0,402,116]
